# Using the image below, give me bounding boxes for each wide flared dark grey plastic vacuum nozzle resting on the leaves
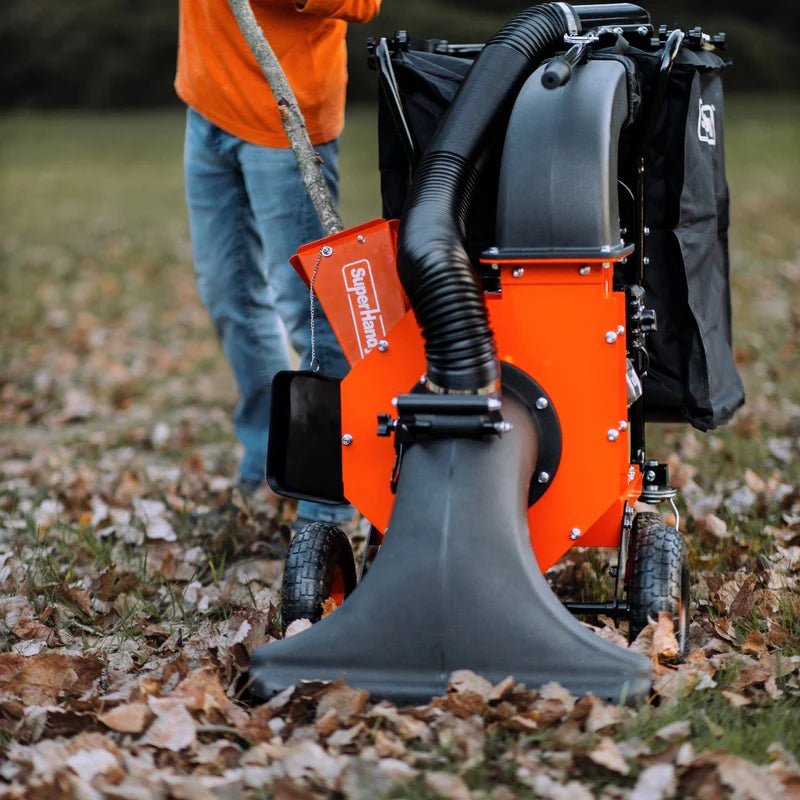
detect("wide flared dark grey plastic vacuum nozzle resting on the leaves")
[250,397,651,704]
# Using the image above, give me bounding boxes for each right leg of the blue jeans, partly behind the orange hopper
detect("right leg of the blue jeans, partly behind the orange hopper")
[240,141,353,522]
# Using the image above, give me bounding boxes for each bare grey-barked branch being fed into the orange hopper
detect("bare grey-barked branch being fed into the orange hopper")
[228,0,344,236]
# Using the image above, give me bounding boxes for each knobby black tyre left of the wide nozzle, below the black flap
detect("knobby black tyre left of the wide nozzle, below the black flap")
[281,522,356,629]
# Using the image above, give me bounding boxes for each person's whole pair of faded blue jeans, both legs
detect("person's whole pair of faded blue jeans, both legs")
[184,108,353,522]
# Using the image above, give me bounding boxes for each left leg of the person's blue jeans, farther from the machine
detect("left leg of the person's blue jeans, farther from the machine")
[184,109,289,480]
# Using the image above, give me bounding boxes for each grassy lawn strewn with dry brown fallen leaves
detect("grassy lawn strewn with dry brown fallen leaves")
[0,96,800,800]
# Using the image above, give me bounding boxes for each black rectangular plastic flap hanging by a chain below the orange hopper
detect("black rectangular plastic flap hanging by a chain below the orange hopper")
[267,370,347,504]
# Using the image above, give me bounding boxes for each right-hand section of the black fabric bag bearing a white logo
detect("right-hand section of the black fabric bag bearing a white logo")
[630,47,744,430]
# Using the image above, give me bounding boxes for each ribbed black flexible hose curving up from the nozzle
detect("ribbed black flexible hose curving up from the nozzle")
[398,3,579,393]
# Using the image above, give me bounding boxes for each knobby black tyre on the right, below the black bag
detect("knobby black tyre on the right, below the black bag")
[628,512,689,656]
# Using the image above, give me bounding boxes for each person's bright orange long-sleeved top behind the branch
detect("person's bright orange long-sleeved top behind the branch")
[175,0,381,147]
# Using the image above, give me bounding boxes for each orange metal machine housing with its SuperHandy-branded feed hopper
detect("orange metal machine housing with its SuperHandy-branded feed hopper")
[290,220,642,571]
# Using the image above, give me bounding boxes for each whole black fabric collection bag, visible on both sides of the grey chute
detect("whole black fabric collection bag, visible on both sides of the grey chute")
[378,39,744,430]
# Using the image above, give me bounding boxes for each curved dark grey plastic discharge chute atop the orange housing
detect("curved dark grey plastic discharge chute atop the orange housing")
[493,61,631,258]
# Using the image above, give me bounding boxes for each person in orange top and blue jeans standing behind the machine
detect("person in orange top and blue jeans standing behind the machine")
[175,0,381,526]
